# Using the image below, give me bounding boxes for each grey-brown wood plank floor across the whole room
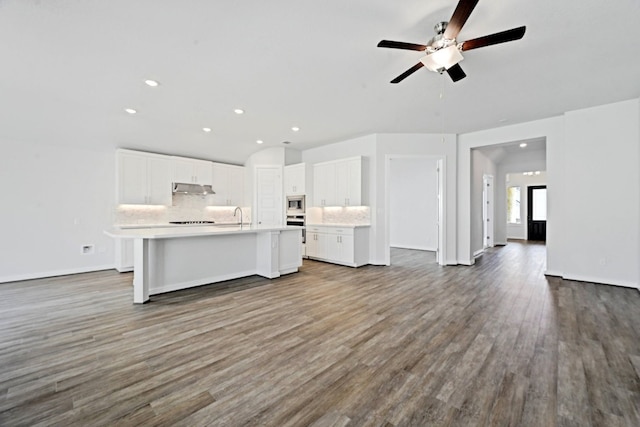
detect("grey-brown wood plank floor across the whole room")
[0,242,640,427]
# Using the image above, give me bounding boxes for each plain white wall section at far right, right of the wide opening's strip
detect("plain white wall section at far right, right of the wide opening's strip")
[563,99,640,287]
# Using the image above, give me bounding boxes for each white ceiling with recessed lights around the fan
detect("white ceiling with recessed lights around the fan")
[0,0,640,163]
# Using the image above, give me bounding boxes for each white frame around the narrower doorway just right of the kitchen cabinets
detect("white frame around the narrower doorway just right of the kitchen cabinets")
[384,154,447,265]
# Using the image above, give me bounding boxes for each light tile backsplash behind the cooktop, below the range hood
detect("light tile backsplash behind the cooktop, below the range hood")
[114,194,251,225]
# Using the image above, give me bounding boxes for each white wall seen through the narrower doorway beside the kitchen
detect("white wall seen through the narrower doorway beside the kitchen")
[389,157,438,251]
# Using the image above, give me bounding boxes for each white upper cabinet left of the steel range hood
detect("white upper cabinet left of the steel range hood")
[116,150,171,206]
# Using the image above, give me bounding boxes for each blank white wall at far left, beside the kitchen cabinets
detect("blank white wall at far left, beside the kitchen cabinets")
[0,141,115,282]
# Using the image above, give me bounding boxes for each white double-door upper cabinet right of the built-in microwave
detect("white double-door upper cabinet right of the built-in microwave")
[313,156,362,207]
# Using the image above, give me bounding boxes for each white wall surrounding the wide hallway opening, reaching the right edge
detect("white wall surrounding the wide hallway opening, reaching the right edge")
[458,99,640,287]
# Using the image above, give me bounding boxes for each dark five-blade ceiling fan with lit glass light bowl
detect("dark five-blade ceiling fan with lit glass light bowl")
[378,0,527,83]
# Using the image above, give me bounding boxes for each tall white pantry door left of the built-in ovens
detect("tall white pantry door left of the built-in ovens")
[256,166,284,226]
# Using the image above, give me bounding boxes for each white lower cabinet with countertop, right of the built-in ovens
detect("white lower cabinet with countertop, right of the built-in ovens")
[306,225,369,267]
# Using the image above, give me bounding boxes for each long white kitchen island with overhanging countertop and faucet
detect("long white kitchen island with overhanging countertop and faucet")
[105,225,302,304]
